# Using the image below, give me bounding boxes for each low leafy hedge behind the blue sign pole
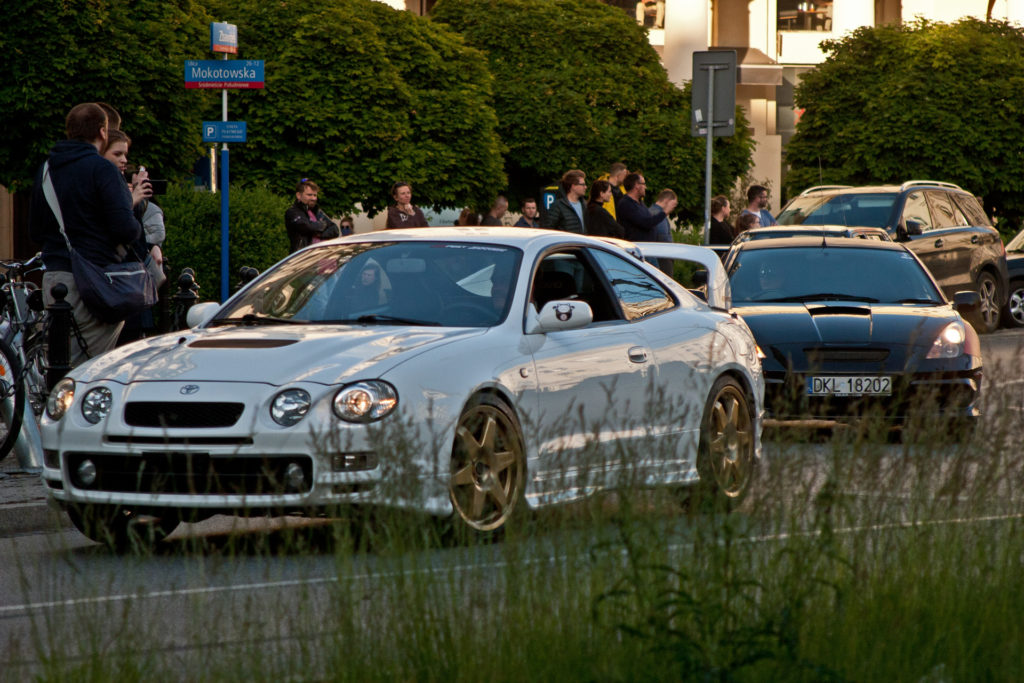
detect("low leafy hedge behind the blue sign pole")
[160,184,291,300]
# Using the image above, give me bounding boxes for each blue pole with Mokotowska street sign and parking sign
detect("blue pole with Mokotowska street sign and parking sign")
[185,22,263,301]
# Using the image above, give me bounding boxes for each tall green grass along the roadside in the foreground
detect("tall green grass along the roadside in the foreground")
[8,358,1024,682]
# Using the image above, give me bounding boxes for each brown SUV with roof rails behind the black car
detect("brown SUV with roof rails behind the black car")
[777,180,1009,332]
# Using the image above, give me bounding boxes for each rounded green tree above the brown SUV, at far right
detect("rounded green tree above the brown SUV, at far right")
[786,18,1024,232]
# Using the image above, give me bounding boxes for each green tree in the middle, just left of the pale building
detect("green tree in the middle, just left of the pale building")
[432,0,754,219]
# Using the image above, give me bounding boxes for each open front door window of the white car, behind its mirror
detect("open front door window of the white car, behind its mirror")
[529,249,622,323]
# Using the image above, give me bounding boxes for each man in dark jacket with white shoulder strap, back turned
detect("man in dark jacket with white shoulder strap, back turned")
[29,102,142,366]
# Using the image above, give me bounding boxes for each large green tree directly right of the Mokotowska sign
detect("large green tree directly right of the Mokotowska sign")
[208,0,505,213]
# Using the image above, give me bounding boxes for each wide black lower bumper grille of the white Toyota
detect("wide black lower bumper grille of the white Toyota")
[65,453,312,496]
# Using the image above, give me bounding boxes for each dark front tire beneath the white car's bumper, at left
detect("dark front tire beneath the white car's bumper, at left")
[67,504,180,552]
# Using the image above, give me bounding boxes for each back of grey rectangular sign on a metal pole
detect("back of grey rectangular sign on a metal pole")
[690,50,736,244]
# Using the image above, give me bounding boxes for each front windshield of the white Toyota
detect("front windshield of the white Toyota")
[210,242,522,327]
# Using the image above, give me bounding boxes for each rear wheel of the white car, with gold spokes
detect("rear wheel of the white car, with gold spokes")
[696,376,757,509]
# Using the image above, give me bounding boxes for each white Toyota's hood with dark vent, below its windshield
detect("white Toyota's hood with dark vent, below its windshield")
[71,326,485,386]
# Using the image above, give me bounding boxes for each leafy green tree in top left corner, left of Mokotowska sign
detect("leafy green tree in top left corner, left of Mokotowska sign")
[0,0,214,189]
